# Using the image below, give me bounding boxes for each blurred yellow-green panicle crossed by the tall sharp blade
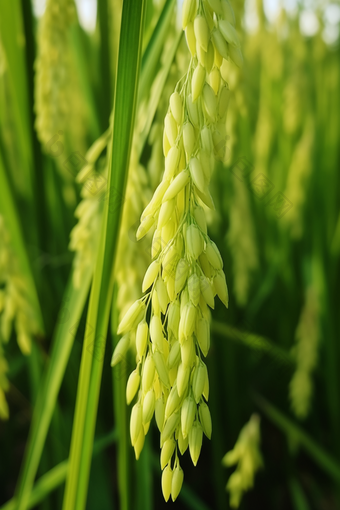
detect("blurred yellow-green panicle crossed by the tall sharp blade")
[69,121,157,310]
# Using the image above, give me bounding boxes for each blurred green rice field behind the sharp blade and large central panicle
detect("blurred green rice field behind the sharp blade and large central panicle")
[0,0,340,510]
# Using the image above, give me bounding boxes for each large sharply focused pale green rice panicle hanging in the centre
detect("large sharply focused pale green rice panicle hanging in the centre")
[112,0,242,500]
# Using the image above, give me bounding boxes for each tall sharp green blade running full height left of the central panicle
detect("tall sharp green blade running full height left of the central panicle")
[63,0,144,510]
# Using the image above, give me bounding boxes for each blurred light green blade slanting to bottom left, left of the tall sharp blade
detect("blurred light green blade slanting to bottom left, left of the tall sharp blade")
[16,274,91,510]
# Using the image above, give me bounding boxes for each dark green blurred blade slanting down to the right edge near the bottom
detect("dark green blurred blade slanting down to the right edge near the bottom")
[253,394,340,482]
